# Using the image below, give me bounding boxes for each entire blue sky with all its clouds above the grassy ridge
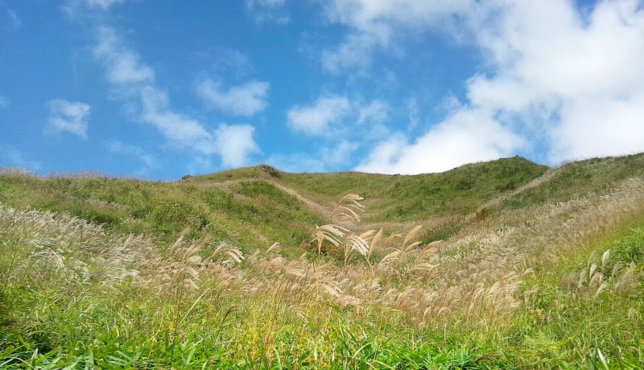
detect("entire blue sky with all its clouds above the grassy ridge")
[0,0,644,180]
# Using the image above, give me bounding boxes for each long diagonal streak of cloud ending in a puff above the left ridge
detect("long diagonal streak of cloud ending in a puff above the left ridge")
[94,27,258,166]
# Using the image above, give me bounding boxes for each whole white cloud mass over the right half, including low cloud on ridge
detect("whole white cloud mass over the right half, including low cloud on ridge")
[323,0,644,172]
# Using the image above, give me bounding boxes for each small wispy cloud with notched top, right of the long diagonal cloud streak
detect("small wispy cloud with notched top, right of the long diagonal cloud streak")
[197,79,269,117]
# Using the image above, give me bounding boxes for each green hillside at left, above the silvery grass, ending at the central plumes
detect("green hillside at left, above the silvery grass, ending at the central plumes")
[0,176,321,250]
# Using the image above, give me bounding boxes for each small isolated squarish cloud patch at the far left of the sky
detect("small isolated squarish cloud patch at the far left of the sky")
[45,99,91,139]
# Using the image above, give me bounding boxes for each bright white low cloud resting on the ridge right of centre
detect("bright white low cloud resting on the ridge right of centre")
[357,110,524,174]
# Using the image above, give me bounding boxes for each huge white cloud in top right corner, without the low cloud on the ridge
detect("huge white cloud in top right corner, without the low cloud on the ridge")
[468,0,644,163]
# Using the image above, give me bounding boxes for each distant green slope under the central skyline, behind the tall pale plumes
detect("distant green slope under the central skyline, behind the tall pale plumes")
[196,157,547,222]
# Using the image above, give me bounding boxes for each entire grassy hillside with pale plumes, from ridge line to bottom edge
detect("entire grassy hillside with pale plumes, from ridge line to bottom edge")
[0,154,644,369]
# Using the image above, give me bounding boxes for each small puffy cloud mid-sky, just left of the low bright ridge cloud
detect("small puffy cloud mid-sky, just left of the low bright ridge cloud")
[288,96,351,135]
